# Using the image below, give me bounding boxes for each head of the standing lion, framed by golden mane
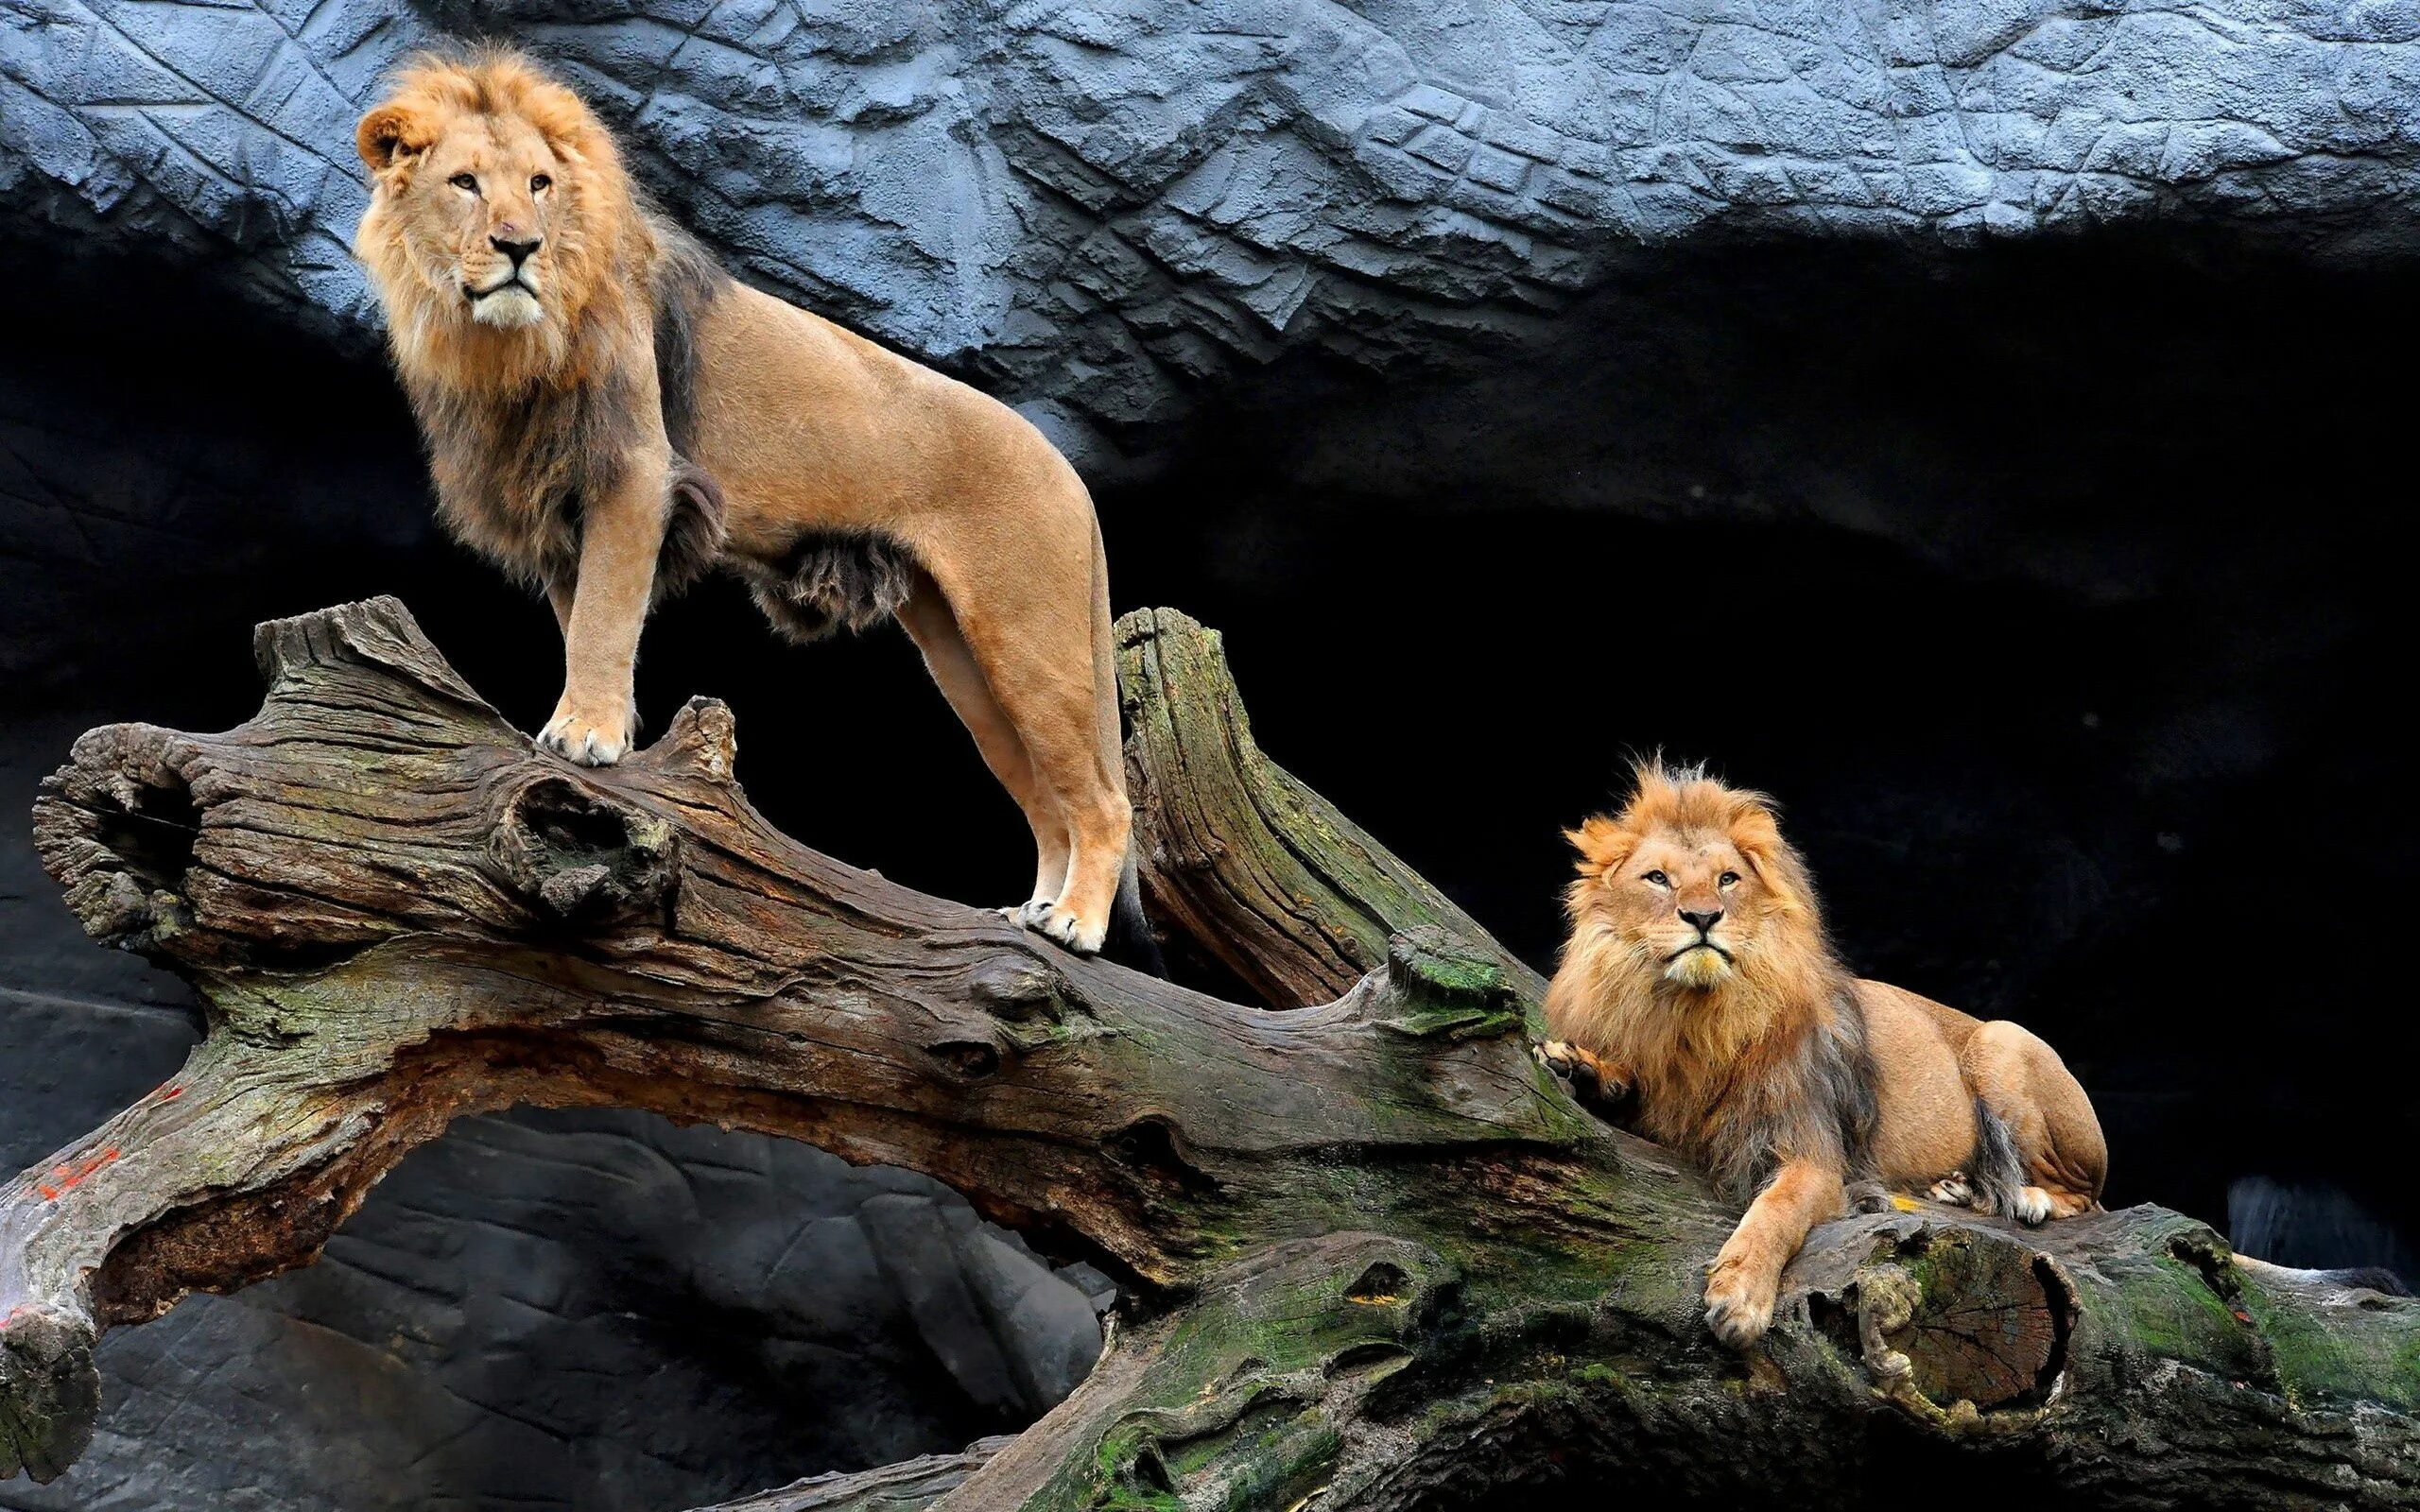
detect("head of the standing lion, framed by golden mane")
[355,56,634,369]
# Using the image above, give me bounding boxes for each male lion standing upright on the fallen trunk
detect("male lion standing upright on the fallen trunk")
[355,51,1147,954]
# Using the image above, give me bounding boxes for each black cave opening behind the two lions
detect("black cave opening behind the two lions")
[0,237,2420,1489]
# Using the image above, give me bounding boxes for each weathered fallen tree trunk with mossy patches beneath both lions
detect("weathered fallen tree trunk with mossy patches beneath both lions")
[0,600,2420,1512]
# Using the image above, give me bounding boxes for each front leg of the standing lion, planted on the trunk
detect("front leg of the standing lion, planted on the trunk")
[537,442,670,767]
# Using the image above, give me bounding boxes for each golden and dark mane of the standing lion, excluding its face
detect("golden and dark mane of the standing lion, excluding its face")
[354,48,729,593]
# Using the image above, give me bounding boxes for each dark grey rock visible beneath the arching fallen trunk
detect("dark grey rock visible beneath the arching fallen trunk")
[0,1113,1098,1512]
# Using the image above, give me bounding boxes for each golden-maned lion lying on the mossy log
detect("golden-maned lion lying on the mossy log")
[1539,765,2108,1348]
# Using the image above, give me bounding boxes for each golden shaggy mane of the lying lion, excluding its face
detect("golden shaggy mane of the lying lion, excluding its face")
[1547,760,1873,1193]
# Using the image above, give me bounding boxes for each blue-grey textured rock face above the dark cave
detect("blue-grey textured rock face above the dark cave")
[0,0,2420,450]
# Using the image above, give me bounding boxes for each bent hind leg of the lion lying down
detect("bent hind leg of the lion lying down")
[1958,1019,2108,1224]
